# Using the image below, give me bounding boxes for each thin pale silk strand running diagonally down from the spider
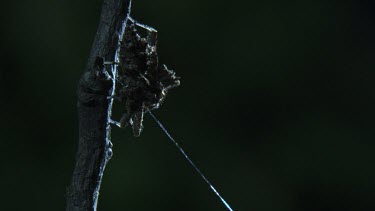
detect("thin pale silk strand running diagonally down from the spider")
[148,111,233,211]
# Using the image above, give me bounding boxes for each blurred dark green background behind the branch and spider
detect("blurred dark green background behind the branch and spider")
[0,0,375,211]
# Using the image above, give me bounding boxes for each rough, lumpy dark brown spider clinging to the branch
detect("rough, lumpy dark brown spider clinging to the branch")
[115,18,180,137]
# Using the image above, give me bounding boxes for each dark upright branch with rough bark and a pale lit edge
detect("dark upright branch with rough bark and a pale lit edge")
[66,0,131,211]
